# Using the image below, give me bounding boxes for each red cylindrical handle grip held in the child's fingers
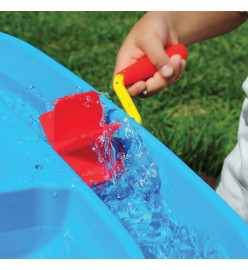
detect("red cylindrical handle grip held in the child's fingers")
[118,44,188,85]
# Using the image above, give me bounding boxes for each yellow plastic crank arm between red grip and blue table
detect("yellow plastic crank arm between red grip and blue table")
[113,74,142,125]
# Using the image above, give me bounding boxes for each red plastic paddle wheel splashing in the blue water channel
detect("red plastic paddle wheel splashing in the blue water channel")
[40,91,123,186]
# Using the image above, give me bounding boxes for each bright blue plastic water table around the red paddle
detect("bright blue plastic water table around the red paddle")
[0,33,248,258]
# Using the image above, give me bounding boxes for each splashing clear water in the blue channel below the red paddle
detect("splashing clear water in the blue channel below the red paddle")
[93,121,225,259]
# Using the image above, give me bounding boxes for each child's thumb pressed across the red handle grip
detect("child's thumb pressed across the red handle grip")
[140,36,173,78]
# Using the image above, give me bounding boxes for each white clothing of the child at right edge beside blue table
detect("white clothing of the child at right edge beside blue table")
[216,77,248,224]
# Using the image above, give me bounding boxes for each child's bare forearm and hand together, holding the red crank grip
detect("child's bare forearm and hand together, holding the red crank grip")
[114,11,247,97]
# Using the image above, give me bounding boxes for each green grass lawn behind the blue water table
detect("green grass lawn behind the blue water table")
[0,12,248,177]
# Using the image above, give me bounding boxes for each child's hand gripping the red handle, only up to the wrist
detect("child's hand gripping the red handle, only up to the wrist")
[114,12,185,97]
